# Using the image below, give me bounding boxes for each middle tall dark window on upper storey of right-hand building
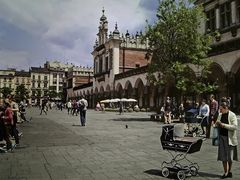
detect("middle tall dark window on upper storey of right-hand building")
[220,2,231,28]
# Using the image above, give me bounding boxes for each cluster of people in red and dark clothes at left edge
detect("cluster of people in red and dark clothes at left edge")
[0,95,28,152]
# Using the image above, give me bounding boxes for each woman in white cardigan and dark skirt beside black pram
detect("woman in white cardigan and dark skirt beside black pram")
[216,102,238,179]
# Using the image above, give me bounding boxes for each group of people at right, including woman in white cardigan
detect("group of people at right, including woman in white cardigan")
[161,95,238,179]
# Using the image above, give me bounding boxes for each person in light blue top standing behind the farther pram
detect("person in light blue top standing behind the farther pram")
[199,99,210,136]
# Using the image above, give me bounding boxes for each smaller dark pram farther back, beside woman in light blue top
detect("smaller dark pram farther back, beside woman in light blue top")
[185,109,205,137]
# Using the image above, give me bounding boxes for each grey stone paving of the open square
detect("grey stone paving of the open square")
[0,108,240,180]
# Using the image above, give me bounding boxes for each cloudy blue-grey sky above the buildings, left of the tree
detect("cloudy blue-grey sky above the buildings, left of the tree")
[0,0,159,70]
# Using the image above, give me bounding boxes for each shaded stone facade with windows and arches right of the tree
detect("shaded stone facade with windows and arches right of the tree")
[196,0,240,111]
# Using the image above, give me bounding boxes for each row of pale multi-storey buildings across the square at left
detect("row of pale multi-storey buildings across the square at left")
[0,61,93,105]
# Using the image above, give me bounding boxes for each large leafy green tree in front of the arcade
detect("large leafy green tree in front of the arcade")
[144,0,216,100]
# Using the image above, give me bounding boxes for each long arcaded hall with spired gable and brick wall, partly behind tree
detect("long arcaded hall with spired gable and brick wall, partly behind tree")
[68,3,240,111]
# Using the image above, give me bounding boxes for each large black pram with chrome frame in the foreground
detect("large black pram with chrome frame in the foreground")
[160,125,202,180]
